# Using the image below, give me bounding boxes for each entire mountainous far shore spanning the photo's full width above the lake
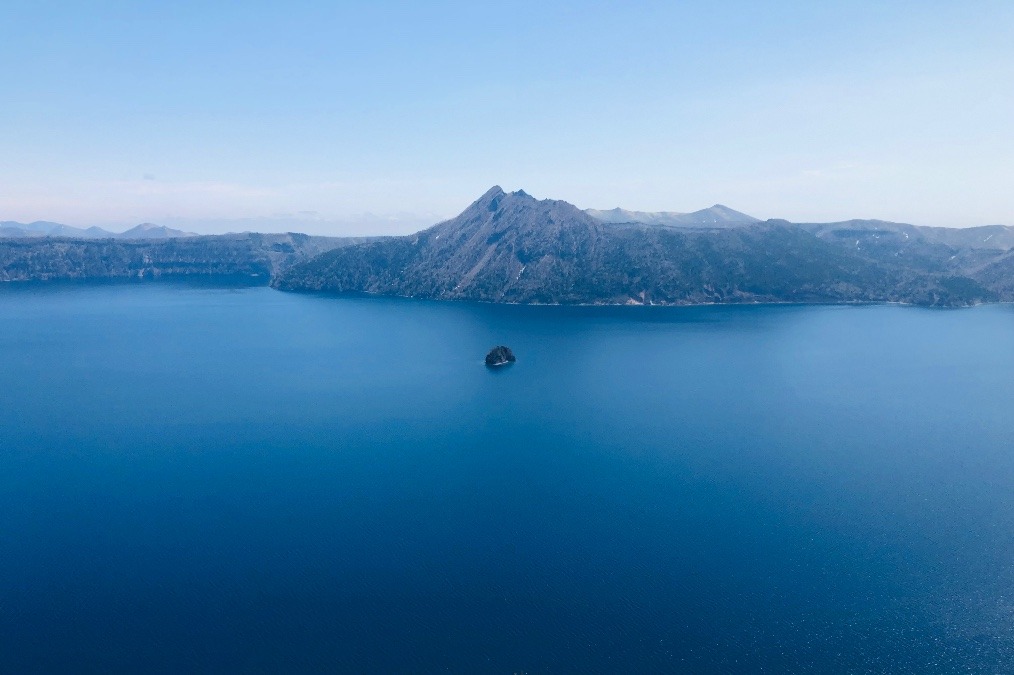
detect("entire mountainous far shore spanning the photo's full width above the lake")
[0,188,1014,306]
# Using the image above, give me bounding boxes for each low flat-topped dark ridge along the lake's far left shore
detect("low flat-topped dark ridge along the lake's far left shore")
[0,234,364,281]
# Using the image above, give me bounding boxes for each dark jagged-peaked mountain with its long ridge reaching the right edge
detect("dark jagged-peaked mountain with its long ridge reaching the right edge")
[273,188,1014,306]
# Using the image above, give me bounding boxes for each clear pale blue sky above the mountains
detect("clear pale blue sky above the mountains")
[0,0,1014,233]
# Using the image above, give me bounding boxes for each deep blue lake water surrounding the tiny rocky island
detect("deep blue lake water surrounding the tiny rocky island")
[0,284,1014,673]
